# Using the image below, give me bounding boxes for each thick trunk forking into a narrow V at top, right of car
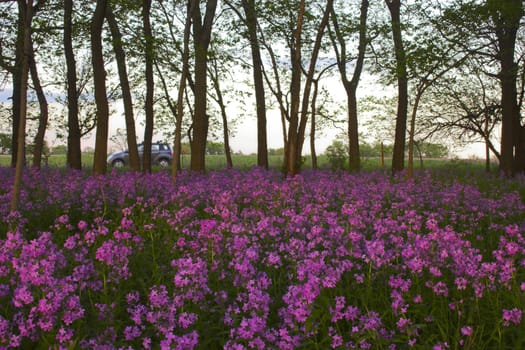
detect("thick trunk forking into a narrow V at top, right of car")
[190,0,217,172]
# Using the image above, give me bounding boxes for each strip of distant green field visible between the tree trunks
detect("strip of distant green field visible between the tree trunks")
[0,153,490,170]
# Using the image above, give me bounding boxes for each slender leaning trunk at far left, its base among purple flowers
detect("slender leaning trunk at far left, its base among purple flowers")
[11,0,33,212]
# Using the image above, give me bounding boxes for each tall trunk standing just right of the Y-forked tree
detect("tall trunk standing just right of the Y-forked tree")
[385,0,408,172]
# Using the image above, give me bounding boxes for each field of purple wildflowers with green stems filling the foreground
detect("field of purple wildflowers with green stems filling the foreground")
[0,168,525,350]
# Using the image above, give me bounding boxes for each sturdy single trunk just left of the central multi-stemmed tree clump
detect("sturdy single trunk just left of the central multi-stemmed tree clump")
[242,0,268,169]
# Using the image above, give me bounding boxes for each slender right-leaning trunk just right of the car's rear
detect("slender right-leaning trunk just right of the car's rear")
[172,0,197,178]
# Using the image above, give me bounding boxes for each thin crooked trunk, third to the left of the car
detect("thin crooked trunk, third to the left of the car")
[29,38,49,168]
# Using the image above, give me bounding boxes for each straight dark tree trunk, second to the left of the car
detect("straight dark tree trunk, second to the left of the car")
[64,0,82,170]
